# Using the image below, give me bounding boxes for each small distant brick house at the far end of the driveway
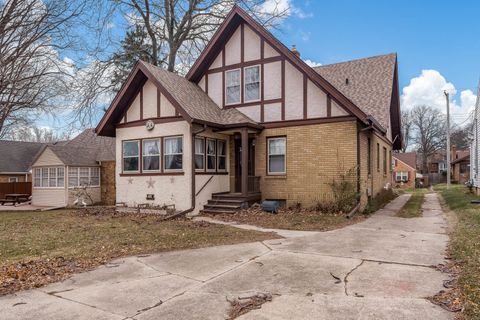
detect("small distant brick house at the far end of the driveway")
[393,152,417,188]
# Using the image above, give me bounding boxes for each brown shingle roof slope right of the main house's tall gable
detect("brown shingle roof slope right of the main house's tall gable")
[314,53,396,129]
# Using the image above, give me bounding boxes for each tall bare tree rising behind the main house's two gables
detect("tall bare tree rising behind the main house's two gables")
[71,0,291,124]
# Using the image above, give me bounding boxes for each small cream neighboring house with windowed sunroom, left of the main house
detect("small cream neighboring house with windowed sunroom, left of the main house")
[32,129,115,207]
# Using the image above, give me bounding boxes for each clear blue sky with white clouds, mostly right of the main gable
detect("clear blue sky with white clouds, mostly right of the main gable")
[40,0,480,132]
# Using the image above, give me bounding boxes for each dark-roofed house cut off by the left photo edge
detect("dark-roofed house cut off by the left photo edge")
[0,140,44,182]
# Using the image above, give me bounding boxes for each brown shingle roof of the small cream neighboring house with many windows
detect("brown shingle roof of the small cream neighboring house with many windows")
[48,129,115,166]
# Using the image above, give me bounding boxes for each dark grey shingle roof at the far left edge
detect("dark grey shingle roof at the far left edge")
[0,140,44,173]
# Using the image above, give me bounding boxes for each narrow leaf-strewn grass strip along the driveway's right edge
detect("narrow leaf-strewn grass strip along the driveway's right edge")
[435,185,480,319]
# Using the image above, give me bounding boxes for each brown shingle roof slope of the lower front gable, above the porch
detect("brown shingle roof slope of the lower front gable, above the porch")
[139,61,256,125]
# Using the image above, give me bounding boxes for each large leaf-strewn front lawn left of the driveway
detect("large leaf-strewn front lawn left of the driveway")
[0,210,278,295]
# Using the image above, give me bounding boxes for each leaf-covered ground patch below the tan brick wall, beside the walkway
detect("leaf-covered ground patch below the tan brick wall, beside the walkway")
[207,207,366,231]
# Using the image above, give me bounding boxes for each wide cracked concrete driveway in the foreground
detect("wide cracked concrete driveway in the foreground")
[0,194,452,320]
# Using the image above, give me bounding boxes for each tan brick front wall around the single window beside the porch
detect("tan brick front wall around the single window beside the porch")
[255,121,357,207]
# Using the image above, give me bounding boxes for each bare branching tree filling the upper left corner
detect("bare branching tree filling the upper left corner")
[0,0,92,136]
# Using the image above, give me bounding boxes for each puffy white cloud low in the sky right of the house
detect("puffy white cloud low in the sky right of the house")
[401,70,476,124]
